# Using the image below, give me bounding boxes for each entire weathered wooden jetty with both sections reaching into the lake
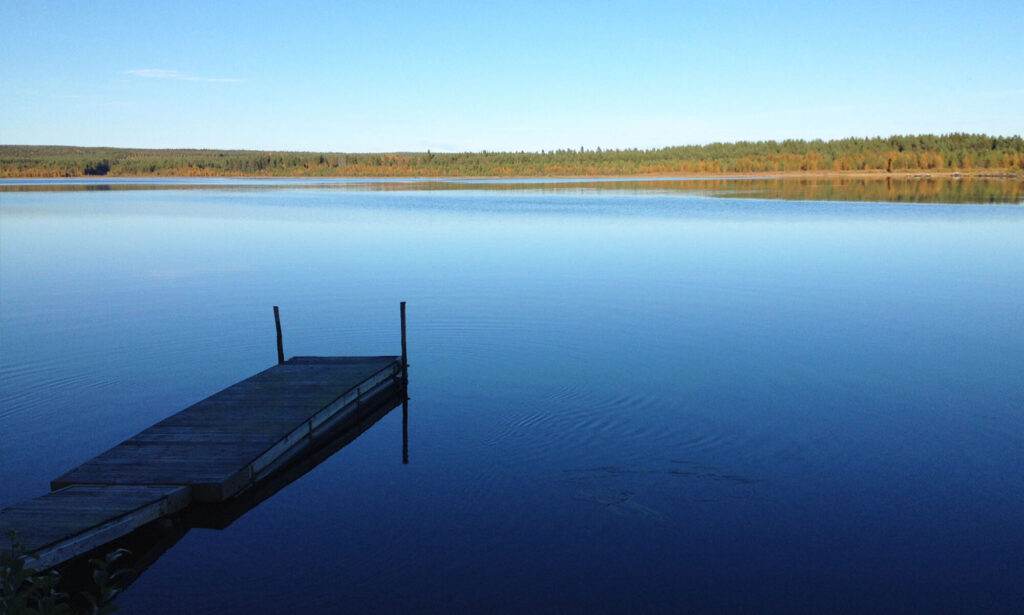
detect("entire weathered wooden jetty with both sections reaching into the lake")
[0,304,407,569]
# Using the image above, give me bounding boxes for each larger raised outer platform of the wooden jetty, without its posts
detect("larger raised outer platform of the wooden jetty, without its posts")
[51,356,400,501]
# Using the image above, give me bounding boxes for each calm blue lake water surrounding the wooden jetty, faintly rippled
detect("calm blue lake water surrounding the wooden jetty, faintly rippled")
[0,180,1024,613]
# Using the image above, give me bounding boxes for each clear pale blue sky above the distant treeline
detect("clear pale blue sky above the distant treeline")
[0,0,1024,152]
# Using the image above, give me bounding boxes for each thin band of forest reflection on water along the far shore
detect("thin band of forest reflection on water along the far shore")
[0,175,1024,204]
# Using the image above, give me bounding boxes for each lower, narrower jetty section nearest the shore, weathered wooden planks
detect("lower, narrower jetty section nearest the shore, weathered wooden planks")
[0,485,189,568]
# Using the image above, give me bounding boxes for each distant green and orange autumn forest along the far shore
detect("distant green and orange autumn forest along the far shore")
[0,133,1024,177]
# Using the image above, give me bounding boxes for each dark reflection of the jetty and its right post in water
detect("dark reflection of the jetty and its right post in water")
[59,379,409,596]
